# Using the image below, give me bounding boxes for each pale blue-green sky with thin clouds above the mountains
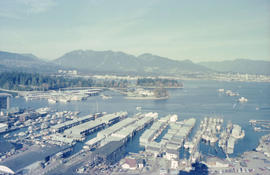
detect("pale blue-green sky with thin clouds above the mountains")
[0,0,270,62]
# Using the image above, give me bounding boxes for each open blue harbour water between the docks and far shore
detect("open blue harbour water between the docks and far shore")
[6,81,270,156]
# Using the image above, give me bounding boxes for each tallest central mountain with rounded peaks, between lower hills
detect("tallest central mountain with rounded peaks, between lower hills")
[54,50,211,75]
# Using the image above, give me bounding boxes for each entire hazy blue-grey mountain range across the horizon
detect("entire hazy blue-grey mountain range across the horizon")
[0,50,270,75]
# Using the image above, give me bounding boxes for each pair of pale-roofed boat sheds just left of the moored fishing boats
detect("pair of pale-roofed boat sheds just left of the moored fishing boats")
[140,115,196,160]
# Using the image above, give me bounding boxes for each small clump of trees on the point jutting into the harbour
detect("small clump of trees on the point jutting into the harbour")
[137,78,183,88]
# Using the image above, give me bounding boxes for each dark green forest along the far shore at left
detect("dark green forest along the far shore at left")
[0,72,127,91]
